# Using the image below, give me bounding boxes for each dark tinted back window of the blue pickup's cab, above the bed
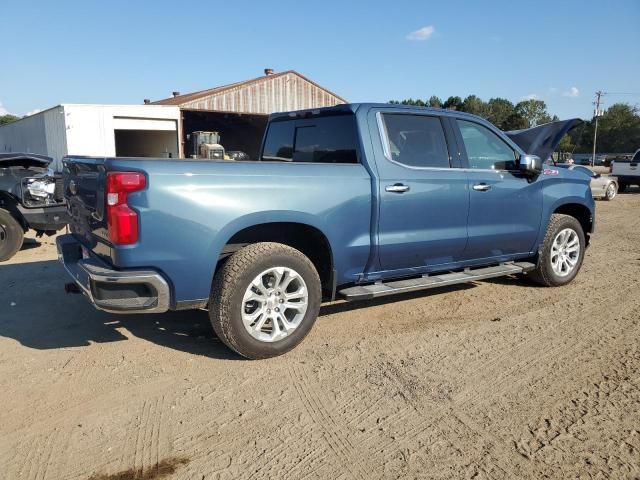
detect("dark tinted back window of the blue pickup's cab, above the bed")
[262,115,358,163]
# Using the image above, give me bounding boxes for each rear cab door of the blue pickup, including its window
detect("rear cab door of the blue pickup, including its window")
[372,111,469,276]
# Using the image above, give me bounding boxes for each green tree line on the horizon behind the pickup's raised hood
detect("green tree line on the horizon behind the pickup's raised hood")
[389,95,640,153]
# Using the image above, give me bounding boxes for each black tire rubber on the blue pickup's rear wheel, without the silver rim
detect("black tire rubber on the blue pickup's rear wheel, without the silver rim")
[209,242,322,359]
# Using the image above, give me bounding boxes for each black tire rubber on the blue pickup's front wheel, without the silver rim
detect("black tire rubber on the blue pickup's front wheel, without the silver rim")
[527,213,586,287]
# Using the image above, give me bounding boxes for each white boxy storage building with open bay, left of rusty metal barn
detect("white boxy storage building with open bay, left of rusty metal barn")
[0,104,183,170]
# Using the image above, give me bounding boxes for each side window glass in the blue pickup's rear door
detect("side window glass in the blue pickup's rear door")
[383,113,450,168]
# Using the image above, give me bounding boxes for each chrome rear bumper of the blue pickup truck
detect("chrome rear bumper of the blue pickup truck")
[56,235,171,313]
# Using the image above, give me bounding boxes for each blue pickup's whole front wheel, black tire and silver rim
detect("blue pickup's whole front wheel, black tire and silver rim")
[528,213,586,287]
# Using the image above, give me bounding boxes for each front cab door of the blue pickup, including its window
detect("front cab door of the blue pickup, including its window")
[451,119,542,260]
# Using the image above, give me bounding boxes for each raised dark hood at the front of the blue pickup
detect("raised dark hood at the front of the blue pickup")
[505,118,583,162]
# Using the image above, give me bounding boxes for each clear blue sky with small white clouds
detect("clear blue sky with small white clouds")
[0,0,640,118]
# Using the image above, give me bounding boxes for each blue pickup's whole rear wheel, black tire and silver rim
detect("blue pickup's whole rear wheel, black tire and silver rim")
[209,242,322,359]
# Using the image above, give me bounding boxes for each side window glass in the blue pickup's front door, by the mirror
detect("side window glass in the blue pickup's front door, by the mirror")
[457,120,517,170]
